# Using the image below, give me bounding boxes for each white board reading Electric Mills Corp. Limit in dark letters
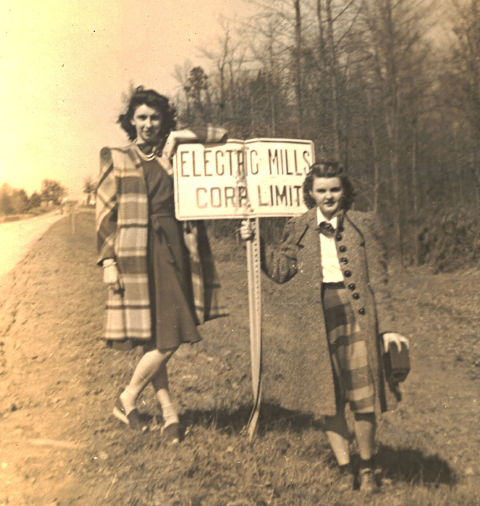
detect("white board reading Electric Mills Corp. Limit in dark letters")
[174,139,315,220]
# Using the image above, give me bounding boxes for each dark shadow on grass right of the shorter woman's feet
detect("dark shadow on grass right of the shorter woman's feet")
[376,444,457,485]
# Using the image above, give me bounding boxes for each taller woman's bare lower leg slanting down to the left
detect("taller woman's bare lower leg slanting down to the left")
[120,348,176,414]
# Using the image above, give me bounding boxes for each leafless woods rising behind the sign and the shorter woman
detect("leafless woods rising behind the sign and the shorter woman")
[175,0,480,268]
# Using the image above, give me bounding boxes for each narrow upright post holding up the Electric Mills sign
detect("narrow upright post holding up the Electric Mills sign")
[247,218,262,441]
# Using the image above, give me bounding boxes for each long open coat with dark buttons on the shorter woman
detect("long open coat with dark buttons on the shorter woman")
[263,208,398,416]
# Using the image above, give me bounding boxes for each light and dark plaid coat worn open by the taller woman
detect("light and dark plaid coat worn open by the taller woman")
[96,127,226,340]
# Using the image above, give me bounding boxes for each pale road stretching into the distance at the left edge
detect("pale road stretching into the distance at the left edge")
[0,213,65,278]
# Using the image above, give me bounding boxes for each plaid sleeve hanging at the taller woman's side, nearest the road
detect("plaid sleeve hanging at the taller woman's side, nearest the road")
[95,148,118,265]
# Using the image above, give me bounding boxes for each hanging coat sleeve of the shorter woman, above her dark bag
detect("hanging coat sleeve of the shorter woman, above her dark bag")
[365,213,395,334]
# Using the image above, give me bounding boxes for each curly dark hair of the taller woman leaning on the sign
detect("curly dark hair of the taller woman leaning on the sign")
[117,86,177,148]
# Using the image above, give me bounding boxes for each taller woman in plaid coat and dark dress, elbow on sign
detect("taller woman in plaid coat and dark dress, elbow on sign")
[96,87,226,442]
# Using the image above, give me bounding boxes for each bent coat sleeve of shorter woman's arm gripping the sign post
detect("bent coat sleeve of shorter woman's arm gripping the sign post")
[261,219,299,283]
